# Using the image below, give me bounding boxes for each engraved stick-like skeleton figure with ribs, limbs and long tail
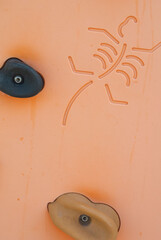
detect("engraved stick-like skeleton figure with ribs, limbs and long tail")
[63,16,161,125]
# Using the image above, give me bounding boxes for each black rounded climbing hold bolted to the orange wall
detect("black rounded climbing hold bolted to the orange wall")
[0,58,44,98]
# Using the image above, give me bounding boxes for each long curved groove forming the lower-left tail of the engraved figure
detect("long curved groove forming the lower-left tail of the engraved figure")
[63,81,93,125]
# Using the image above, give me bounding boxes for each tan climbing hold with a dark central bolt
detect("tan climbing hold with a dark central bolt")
[47,193,120,240]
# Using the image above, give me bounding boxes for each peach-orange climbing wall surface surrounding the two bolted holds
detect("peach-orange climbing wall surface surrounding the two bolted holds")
[0,0,161,240]
